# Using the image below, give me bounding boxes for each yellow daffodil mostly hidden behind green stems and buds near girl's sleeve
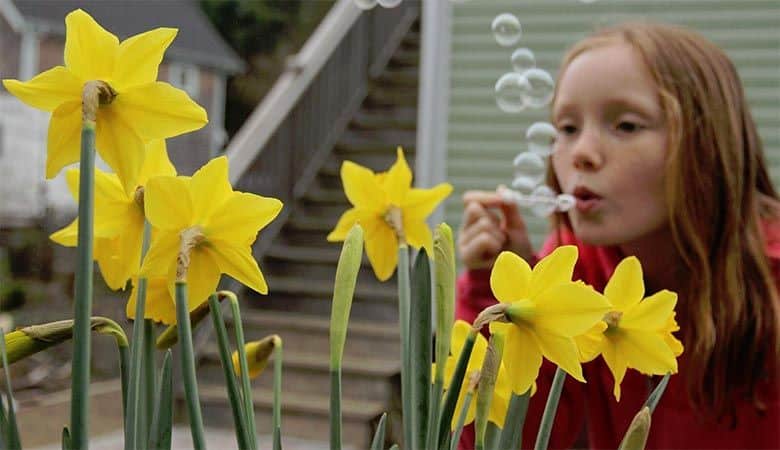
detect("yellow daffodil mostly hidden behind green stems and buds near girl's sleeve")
[431,320,512,430]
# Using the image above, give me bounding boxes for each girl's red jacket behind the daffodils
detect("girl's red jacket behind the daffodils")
[456,226,780,450]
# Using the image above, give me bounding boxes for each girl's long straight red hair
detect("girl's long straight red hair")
[548,22,780,417]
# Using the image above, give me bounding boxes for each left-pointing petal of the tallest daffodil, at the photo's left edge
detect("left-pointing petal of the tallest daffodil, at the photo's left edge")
[3,66,84,111]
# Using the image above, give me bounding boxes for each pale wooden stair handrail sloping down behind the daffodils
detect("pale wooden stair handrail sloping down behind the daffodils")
[225,0,362,184]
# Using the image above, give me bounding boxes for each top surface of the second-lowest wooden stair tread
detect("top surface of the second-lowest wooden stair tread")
[203,346,401,378]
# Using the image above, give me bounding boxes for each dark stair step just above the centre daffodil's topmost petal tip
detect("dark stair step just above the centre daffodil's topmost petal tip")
[334,130,417,159]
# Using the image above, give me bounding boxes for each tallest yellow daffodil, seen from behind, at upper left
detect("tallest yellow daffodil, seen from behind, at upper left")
[3,9,208,194]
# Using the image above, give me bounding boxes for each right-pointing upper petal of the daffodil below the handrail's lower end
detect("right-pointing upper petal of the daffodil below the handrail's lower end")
[205,192,282,244]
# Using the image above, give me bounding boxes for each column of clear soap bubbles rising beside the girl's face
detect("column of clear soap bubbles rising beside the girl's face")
[491,13,576,217]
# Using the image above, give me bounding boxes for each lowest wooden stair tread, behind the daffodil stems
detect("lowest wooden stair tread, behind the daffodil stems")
[198,383,387,420]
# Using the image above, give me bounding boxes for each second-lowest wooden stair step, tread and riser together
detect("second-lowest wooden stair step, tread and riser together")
[198,346,401,403]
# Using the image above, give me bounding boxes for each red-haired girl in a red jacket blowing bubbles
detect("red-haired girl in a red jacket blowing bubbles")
[457,23,780,449]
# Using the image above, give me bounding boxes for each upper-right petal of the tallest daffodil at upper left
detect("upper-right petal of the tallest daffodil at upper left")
[113,28,178,90]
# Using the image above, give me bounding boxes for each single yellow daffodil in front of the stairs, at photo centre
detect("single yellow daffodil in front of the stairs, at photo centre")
[328,147,452,281]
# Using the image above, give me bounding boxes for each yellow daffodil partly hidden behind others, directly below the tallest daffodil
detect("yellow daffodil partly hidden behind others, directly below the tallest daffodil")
[51,140,176,290]
